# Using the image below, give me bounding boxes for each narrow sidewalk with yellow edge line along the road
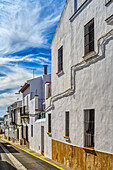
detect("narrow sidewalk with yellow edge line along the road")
[0,137,72,170]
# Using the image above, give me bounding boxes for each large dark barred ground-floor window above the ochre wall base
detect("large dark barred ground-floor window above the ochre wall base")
[84,109,95,147]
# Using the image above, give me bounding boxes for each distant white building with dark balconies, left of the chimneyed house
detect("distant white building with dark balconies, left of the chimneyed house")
[4,101,22,143]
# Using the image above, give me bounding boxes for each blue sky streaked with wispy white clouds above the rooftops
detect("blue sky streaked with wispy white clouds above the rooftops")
[0,0,66,116]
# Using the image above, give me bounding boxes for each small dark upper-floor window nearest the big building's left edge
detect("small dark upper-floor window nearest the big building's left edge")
[58,46,63,72]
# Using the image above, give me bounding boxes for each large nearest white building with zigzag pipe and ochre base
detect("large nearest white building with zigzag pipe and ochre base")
[45,0,113,170]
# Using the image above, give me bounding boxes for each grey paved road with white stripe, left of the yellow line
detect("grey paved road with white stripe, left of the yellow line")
[0,140,60,170]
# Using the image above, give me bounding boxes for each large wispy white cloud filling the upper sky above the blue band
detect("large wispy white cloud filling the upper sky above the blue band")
[0,0,62,54]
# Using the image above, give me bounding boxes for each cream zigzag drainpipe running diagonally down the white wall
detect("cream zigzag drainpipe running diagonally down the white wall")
[45,29,113,111]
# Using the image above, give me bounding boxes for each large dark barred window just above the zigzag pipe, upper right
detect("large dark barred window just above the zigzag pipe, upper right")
[84,19,94,55]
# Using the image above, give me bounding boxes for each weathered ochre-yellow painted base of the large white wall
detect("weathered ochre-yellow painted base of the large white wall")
[52,140,113,170]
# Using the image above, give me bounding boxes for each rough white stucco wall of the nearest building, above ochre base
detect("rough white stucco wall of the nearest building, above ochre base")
[51,0,113,153]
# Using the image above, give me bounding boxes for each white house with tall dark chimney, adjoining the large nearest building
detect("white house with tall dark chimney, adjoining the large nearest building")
[20,66,51,150]
